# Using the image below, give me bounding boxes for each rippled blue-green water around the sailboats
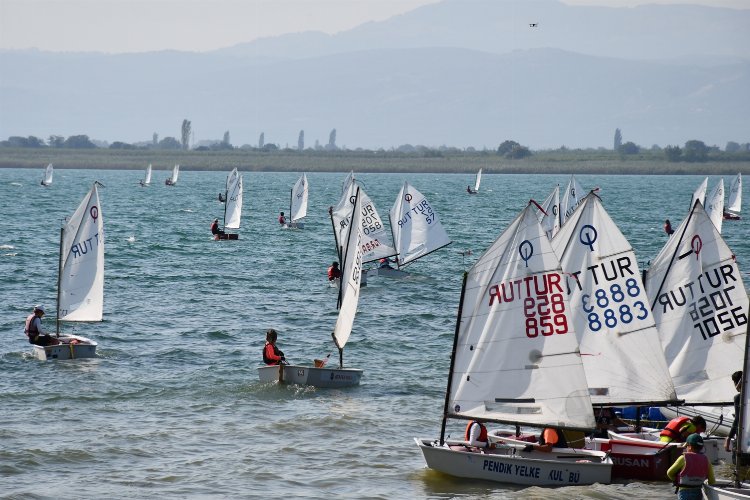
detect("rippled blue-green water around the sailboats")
[0,166,750,499]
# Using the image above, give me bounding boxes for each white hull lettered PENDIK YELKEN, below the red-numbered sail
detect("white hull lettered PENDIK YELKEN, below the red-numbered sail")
[414,438,612,486]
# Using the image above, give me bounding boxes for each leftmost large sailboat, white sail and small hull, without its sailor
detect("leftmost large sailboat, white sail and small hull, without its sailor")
[34,182,104,360]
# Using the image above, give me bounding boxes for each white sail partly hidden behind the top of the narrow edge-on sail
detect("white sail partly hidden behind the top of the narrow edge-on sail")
[331,182,396,263]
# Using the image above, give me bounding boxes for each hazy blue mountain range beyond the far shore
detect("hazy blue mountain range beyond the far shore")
[0,0,750,149]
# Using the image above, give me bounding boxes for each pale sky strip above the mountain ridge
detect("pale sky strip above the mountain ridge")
[0,0,750,53]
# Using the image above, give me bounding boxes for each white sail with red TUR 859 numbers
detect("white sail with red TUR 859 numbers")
[447,205,595,428]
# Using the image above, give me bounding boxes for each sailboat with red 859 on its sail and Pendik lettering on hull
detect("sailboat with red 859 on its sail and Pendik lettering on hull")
[415,202,612,486]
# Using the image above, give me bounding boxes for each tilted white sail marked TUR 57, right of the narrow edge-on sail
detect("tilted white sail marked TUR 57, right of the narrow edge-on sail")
[390,182,451,266]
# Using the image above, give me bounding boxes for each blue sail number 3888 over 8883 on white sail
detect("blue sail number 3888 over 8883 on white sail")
[581,278,648,332]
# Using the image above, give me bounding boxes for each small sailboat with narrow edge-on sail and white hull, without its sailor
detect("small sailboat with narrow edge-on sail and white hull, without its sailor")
[258,191,363,388]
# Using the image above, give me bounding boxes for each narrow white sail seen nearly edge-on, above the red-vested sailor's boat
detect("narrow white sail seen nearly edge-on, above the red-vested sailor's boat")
[333,191,362,349]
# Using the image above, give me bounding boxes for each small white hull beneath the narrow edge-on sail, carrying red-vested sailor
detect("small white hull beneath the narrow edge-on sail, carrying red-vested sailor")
[258,365,364,389]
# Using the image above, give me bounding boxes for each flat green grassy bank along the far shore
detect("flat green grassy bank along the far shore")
[0,148,750,175]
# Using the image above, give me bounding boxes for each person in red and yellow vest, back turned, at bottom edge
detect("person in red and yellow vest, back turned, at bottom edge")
[667,433,716,500]
